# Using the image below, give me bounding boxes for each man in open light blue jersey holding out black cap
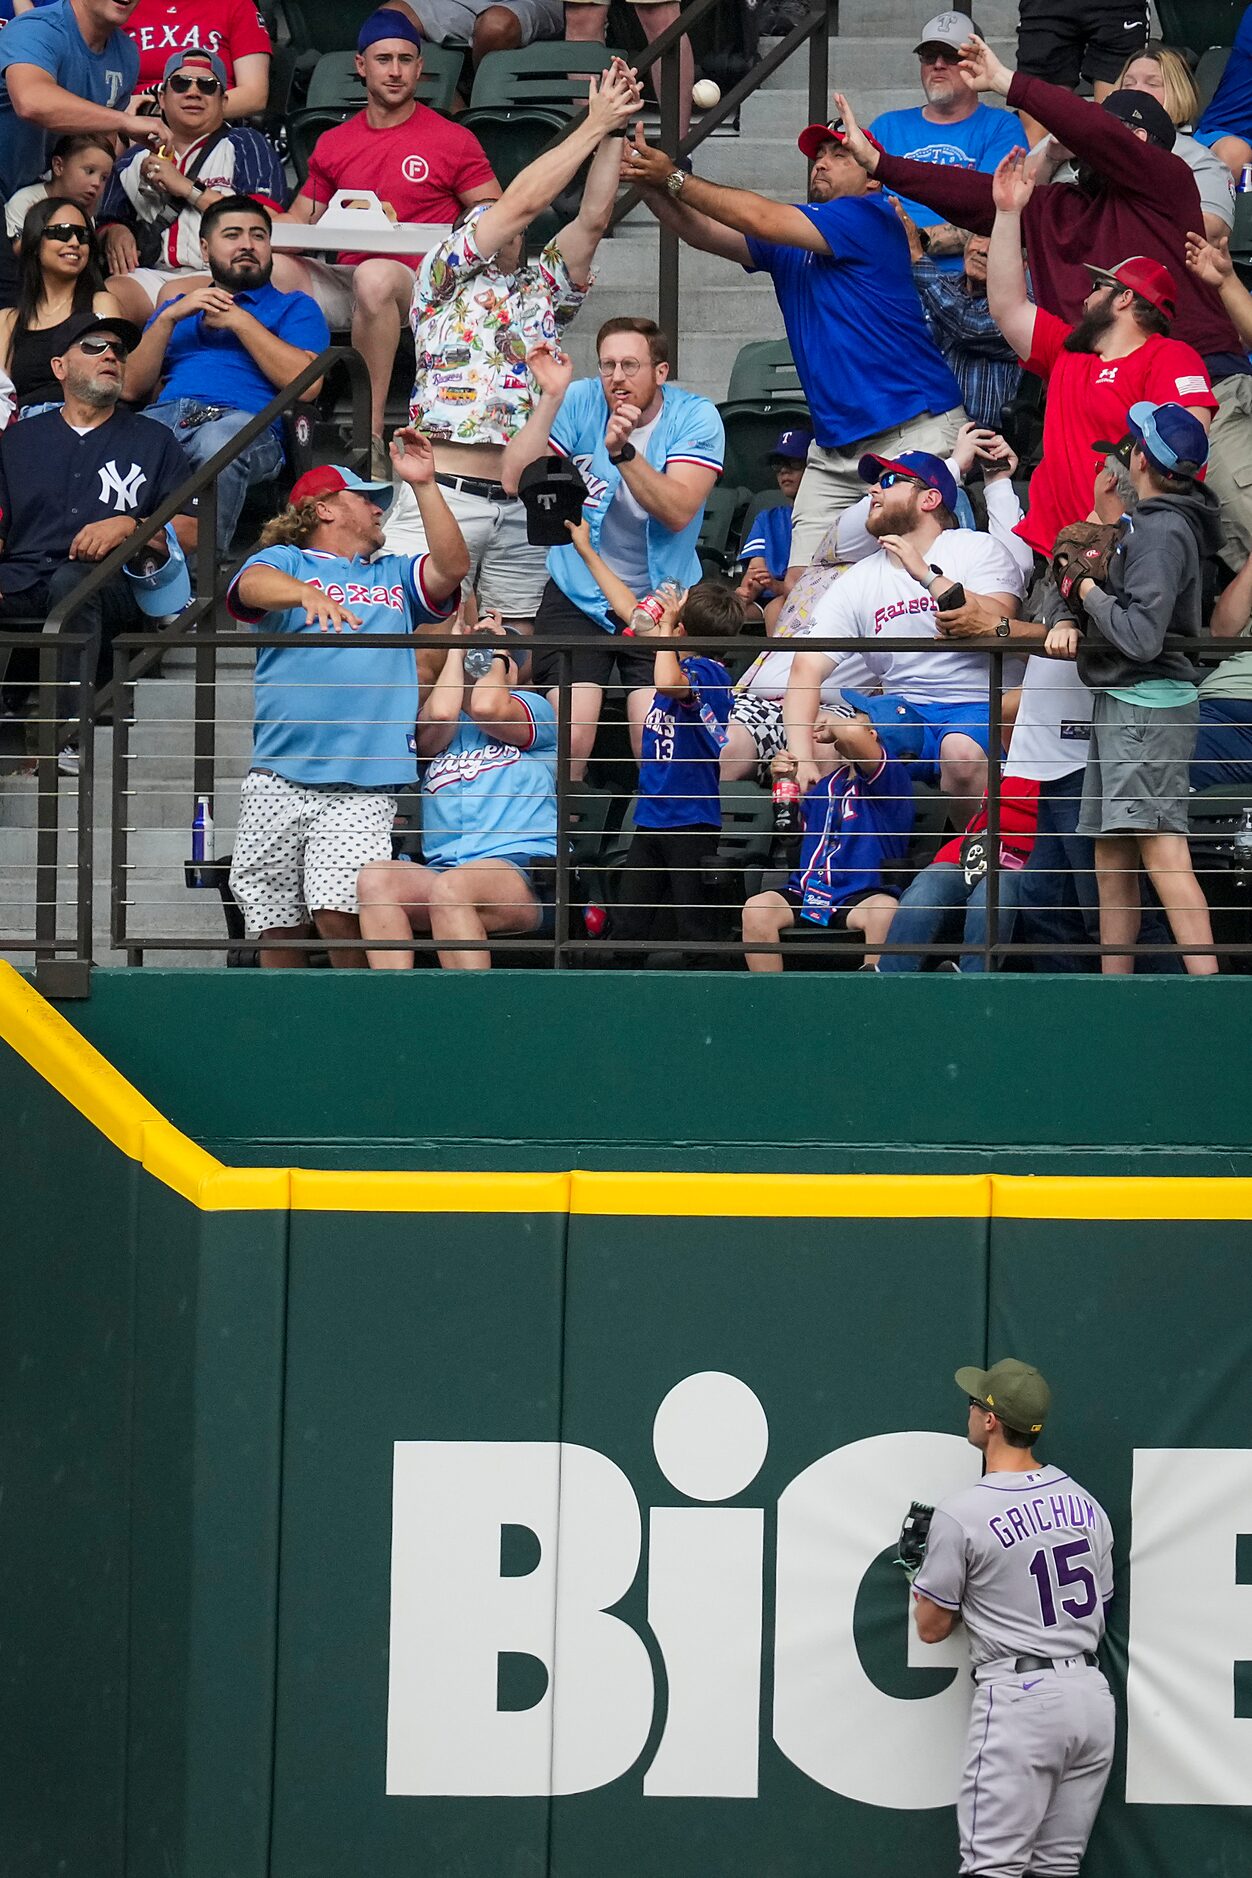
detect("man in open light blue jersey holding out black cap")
[501,317,726,781]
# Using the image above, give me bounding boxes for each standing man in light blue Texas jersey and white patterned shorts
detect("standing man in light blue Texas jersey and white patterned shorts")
[227,430,469,965]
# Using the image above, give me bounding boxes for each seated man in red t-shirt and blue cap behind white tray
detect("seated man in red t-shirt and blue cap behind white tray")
[274,8,499,477]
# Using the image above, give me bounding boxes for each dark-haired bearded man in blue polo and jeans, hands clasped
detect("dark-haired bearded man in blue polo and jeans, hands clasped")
[126,195,330,552]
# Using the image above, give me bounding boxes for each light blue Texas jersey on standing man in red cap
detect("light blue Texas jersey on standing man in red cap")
[227,546,456,789]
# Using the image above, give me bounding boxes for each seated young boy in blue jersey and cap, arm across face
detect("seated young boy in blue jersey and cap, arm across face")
[743,691,925,971]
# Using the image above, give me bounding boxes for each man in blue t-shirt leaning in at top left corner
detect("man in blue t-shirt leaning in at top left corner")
[0,0,156,197]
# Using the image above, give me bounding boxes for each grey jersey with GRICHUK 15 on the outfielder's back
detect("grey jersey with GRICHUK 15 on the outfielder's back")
[912,1467,1113,1666]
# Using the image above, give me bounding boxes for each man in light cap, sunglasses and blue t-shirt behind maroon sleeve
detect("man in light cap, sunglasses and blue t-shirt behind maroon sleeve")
[867,13,1025,274]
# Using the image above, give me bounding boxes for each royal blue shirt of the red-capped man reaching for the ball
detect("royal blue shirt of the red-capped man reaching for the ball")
[750,193,961,450]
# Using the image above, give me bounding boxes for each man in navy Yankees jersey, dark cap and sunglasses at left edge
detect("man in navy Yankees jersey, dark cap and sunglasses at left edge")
[0,314,195,732]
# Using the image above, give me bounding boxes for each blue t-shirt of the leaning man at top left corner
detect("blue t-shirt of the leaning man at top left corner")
[0,0,139,197]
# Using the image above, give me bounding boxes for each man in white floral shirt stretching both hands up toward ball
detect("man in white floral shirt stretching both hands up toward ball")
[387,60,640,623]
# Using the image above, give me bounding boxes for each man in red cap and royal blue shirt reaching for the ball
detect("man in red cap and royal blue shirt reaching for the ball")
[625,124,965,573]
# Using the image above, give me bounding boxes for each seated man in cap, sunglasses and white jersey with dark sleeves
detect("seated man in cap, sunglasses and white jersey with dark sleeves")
[98,47,287,325]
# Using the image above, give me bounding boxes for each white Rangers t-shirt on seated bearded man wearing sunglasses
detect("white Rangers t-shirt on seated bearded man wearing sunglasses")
[813,528,1025,704]
